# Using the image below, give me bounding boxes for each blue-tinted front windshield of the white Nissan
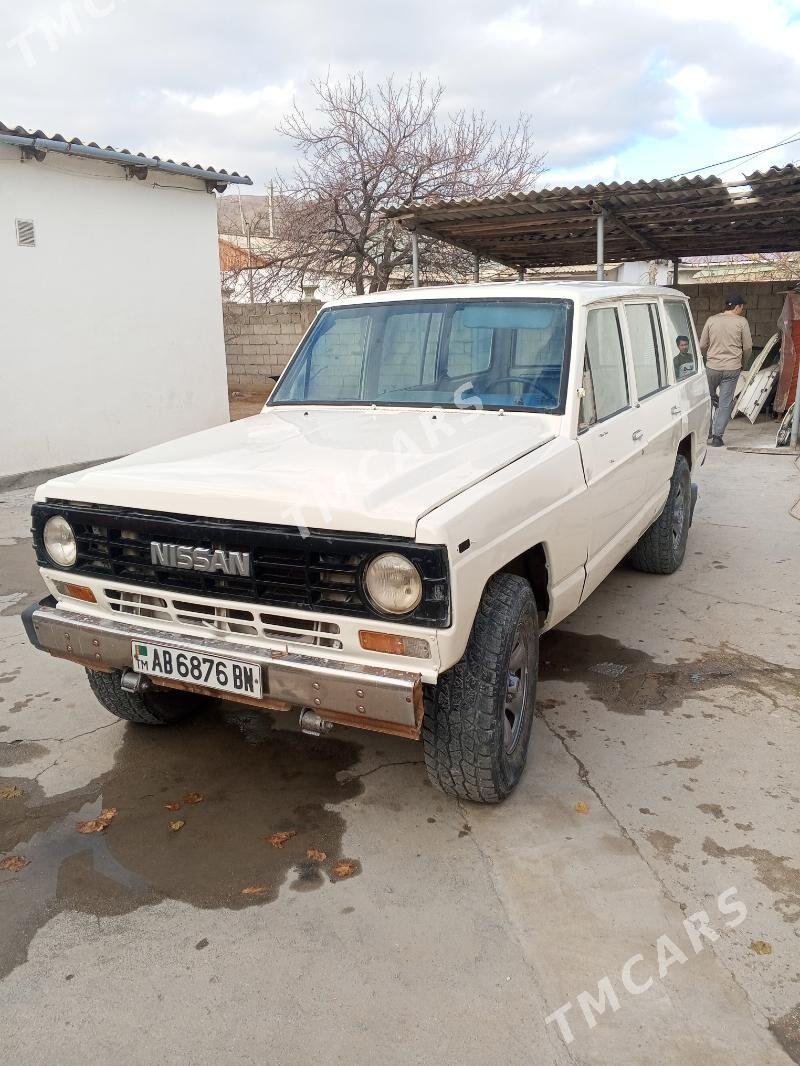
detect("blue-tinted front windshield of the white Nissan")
[269,297,572,413]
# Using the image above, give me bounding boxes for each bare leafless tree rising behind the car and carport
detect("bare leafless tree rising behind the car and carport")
[231,75,543,298]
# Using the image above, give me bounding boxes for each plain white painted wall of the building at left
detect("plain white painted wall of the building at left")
[0,145,228,477]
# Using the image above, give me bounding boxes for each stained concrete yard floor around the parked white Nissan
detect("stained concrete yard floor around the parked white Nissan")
[0,423,800,1066]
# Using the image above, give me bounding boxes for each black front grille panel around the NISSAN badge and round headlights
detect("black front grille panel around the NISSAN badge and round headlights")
[32,501,450,627]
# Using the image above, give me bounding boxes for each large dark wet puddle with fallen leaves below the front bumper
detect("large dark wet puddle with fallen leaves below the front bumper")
[0,705,364,976]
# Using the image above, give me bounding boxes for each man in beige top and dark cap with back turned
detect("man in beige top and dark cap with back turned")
[700,292,753,448]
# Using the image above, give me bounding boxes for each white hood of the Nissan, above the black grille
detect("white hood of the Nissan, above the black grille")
[36,407,560,537]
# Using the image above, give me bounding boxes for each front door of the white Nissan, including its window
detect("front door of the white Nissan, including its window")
[578,305,644,599]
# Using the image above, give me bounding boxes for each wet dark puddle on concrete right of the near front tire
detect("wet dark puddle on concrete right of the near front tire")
[540,629,800,714]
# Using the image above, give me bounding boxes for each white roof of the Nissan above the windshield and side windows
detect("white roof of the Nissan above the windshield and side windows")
[324,281,688,307]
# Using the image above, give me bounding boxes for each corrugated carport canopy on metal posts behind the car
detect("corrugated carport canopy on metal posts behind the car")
[386,165,800,280]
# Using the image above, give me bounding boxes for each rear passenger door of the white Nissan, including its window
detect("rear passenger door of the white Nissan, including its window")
[625,300,682,520]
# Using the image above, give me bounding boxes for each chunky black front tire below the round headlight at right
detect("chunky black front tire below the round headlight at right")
[422,574,539,803]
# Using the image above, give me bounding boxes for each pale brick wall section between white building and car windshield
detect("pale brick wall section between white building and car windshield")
[223,300,321,390]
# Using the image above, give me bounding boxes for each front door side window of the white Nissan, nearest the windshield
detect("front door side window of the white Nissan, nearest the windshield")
[578,307,630,430]
